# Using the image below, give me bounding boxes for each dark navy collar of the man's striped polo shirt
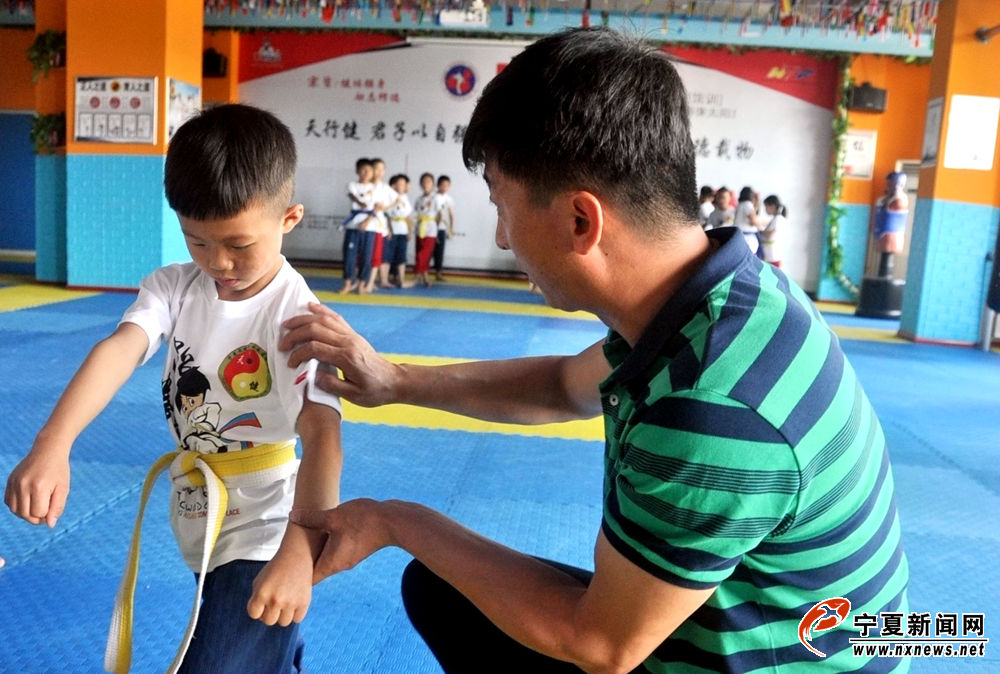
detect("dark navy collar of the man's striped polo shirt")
[604,227,754,385]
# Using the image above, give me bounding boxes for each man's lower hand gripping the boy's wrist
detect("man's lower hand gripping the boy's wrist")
[288,499,393,584]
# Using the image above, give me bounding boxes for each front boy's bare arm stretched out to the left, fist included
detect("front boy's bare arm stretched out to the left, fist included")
[4,323,149,527]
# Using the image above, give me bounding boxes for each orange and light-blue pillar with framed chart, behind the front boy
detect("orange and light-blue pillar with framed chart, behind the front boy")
[65,0,204,287]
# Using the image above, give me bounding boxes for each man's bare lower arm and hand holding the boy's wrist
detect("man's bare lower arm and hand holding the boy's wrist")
[291,500,714,672]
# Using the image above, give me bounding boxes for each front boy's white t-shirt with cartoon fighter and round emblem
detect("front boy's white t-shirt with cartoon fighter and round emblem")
[121,260,341,571]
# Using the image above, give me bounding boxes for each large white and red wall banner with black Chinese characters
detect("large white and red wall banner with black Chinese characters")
[240,32,835,288]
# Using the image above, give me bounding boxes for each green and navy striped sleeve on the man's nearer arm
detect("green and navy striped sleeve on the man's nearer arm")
[602,391,800,589]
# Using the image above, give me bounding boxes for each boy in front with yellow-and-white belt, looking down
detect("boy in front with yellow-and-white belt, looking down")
[5,105,341,672]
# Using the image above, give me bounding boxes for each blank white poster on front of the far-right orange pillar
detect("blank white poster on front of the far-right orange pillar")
[944,95,1000,171]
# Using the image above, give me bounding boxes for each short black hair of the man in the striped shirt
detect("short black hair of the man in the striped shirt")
[462,28,698,236]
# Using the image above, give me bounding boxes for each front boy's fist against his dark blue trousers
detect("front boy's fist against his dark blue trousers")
[247,550,313,627]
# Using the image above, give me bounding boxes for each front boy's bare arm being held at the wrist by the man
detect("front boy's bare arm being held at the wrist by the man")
[247,397,343,626]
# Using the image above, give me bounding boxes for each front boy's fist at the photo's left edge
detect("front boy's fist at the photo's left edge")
[3,440,69,528]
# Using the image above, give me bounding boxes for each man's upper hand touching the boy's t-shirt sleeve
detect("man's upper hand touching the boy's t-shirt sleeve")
[278,303,400,407]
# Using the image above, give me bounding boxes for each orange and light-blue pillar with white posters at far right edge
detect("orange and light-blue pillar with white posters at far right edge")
[900,0,1000,344]
